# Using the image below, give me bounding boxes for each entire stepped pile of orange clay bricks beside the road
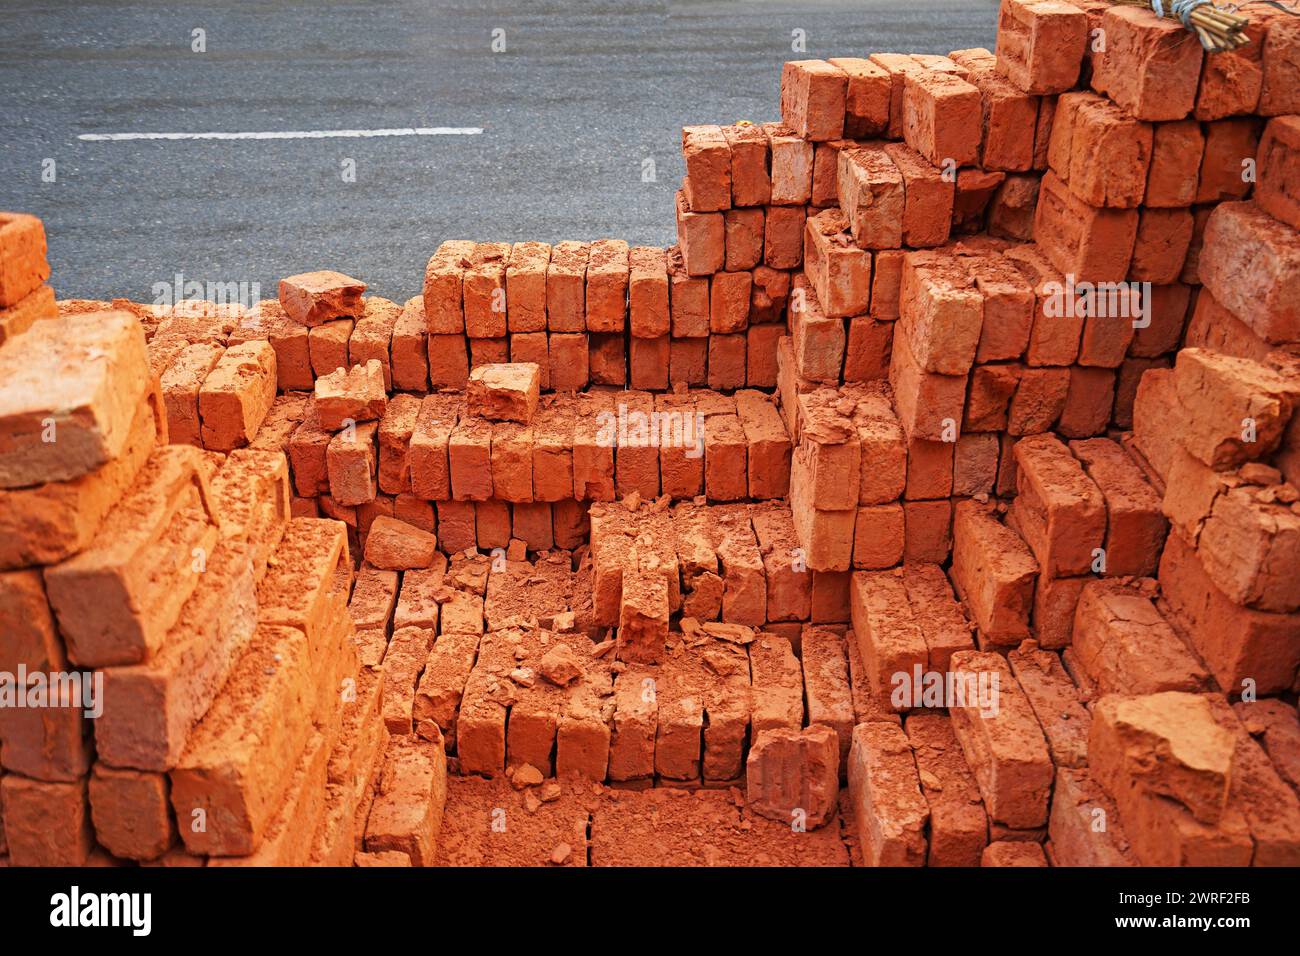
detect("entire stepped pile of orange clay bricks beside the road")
[0,0,1300,866]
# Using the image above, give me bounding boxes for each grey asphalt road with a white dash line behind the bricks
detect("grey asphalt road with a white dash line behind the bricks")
[0,0,997,302]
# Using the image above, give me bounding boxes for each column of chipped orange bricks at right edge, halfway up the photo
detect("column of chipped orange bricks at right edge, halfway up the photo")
[1135,335,1300,695]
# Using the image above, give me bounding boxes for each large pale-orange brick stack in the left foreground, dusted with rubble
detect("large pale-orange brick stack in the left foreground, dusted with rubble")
[0,277,405,865]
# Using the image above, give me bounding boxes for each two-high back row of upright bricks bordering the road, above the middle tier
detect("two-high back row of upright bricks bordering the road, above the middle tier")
[423,234,792,392]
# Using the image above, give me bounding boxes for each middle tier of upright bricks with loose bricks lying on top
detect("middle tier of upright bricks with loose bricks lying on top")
[283,362,789,564]
